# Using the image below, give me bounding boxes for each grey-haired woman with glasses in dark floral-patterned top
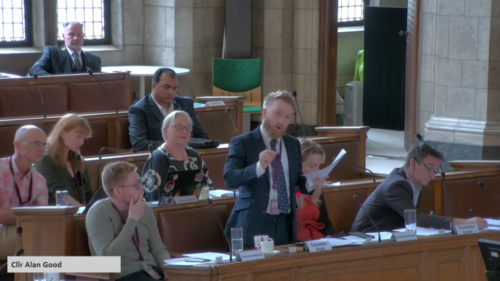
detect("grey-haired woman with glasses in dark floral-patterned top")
[142,110,209,201]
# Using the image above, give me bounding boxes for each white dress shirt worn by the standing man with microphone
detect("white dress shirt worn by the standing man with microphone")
[256,125,290,214]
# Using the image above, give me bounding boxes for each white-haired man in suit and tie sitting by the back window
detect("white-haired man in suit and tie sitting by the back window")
[29,21,101,76]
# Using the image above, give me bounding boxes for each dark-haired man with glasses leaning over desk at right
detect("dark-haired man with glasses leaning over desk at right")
[351,142,487,232]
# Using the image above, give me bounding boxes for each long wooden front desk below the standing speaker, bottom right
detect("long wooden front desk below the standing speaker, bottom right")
[164,232,500,281]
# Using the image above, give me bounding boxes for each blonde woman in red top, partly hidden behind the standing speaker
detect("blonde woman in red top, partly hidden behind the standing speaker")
[296,139,333,241]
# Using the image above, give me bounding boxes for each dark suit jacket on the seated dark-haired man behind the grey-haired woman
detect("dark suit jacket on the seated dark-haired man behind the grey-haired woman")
[128,94,208,151]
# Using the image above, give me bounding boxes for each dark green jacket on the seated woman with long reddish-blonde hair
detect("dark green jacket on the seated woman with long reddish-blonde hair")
[35,155,94,205]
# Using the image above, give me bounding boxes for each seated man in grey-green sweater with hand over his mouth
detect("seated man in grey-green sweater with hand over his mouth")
[85,161,170,281]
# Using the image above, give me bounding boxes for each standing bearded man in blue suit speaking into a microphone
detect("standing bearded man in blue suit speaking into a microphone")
[224,90,324,248]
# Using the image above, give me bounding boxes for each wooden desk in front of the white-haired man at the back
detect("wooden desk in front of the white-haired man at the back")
[0,73,132,118]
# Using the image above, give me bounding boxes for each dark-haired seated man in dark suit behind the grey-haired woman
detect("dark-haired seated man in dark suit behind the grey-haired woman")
[128,68,208,151]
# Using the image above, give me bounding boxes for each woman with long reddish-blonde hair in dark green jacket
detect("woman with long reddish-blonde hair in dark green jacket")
[35,114,94,207]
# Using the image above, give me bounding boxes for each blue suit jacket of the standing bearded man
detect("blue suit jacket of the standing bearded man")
[224,128,306,246]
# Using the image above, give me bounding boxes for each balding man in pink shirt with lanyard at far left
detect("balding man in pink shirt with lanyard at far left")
[0,125,49,260]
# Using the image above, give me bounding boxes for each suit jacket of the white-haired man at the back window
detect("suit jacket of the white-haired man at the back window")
[29,46,101,76]
